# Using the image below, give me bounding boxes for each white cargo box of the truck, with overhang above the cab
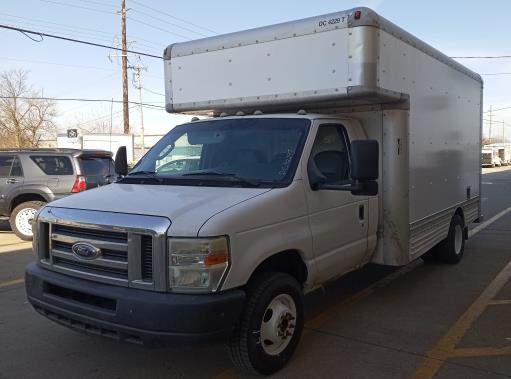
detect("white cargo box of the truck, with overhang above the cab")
[165,8,483,264]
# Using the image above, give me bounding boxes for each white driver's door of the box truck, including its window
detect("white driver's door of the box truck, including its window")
[306,123,368,282]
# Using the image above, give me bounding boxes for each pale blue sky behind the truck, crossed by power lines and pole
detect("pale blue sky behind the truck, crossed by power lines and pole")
[0,0,511,137]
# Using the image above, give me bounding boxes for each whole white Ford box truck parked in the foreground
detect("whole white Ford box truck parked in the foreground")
[26,8,482,374]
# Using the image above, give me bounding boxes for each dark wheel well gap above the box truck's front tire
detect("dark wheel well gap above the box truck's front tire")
[251,250,308,283]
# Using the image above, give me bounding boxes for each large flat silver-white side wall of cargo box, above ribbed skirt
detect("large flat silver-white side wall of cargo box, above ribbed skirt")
[378,31,481,223]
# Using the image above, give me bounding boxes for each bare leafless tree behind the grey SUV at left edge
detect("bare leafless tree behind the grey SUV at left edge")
[0,70,57,148]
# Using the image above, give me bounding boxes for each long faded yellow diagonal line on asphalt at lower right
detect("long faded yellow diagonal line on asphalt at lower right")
[411,261,511,379]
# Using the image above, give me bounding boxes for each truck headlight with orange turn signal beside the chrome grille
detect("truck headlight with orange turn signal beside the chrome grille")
[169,237,229,292]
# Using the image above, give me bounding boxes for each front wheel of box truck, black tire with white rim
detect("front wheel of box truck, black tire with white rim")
[229,272,304,375]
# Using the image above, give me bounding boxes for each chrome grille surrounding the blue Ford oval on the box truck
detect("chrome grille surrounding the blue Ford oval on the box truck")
[37,207,170,291]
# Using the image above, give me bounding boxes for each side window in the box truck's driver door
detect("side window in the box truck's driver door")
[311,125,350,184]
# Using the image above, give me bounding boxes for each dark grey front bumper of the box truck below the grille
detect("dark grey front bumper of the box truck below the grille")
[25,263,245,347]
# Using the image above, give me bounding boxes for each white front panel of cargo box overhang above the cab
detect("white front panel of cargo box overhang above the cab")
[165,29,353,108]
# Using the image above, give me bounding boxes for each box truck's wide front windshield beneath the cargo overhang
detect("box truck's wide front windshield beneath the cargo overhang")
[123,118,310,187]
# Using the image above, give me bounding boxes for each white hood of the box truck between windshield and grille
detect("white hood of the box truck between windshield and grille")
[51,183,271,237]
